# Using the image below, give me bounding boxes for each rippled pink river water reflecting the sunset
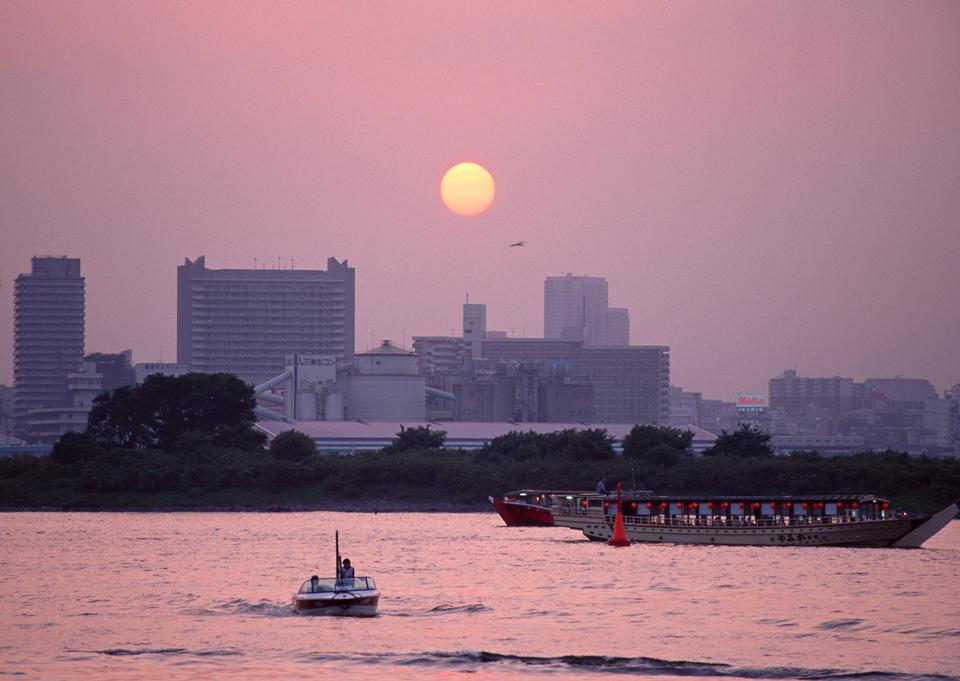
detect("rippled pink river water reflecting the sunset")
[0,513,960,681]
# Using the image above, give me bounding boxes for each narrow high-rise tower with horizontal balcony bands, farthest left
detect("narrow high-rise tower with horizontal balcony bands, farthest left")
[13,257,85,432]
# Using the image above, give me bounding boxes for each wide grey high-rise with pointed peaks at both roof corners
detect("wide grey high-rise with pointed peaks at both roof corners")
[177,256,356,383]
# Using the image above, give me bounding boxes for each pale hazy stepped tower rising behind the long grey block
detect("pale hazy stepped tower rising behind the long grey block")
[543,273,630,347]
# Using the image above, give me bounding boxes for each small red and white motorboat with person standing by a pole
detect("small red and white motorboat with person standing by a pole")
[293,532,380,617]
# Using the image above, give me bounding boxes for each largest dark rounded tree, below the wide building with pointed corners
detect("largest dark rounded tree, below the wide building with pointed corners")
[86,373,266,452]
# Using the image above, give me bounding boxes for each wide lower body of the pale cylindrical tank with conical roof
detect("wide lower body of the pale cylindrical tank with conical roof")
[347,375,426,421]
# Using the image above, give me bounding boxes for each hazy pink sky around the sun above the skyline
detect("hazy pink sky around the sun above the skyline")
[0,0,960,399]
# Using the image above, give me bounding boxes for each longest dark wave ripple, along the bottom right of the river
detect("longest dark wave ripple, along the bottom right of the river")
[312,651,960,681]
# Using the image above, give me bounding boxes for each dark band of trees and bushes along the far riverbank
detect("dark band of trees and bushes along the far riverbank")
[0,374,960,511]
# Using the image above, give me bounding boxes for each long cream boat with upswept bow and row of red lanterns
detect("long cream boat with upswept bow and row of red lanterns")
[552,492,960,548]
